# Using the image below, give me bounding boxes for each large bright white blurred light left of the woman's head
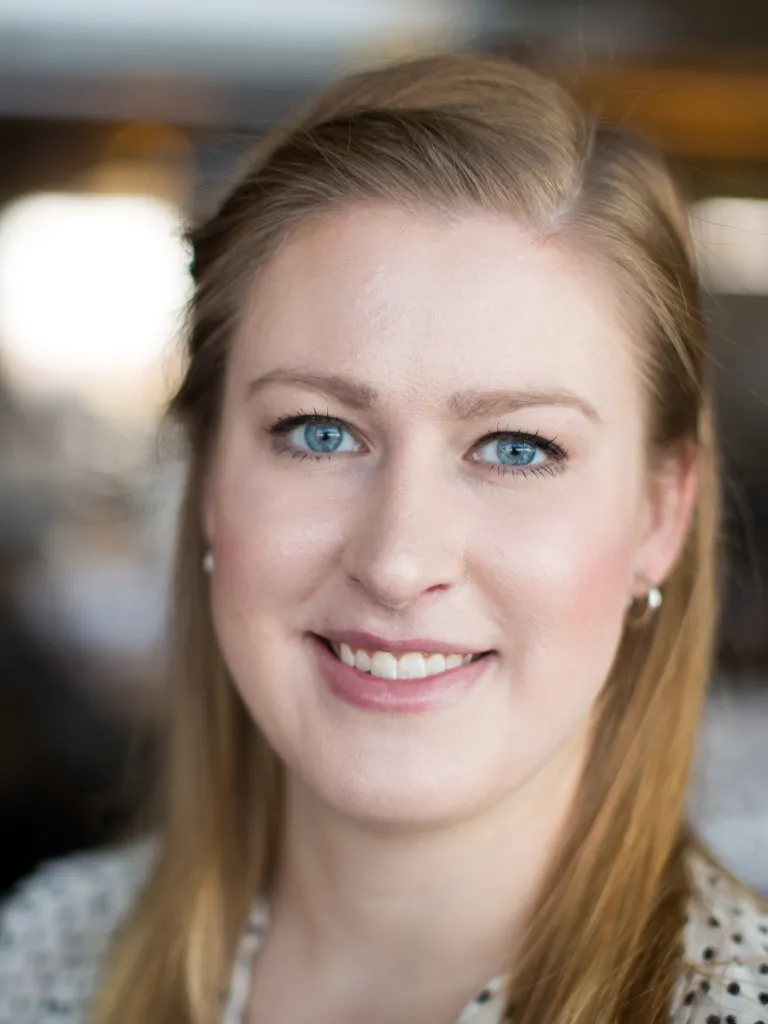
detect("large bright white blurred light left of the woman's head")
[0,193,190,416]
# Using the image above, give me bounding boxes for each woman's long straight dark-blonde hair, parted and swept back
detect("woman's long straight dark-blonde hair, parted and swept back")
[93,54,718,1024]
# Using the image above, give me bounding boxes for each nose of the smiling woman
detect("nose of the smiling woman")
[343,459,465,610]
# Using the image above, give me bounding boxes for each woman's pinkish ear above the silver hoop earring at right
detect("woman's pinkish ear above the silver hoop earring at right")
[632,441,698,597]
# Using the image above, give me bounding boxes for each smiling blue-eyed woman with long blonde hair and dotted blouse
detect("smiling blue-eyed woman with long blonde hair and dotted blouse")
[0,55,768,1024]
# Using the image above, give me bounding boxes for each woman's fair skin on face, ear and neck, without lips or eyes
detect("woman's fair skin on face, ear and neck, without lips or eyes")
[204,206,695,1024]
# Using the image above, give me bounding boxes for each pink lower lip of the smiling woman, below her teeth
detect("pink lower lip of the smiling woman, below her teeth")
[309,634,489,715]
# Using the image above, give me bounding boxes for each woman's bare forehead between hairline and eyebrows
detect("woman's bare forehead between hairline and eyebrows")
[236,208,639,413]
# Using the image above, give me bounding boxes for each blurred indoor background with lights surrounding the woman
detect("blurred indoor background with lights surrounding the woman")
[0,0,768,893]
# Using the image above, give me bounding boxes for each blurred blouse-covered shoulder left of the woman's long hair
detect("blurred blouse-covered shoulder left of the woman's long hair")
[0,839,157,1024]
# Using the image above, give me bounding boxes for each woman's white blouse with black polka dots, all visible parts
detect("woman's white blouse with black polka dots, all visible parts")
[0,841,768,1024]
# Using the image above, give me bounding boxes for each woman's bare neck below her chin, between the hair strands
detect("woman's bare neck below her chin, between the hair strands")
[264,737,586,1011]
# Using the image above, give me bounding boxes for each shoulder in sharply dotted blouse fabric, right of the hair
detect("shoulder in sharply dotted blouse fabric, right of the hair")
[672,856,768,1024]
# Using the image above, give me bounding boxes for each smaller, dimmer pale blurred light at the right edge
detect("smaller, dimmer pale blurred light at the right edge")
[690,196,768,295]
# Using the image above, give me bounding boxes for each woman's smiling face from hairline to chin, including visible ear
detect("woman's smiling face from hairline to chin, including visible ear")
[204,207,690,823]
